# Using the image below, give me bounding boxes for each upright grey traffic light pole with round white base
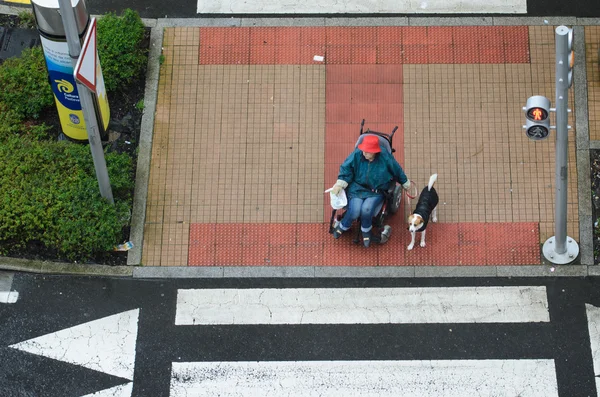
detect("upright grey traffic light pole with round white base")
[542,26,579,264]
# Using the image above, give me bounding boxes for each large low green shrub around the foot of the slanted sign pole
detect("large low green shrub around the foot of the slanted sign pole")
[0,137,134,260]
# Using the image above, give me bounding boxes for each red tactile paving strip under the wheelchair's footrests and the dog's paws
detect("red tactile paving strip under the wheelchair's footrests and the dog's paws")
[188,220,540,266]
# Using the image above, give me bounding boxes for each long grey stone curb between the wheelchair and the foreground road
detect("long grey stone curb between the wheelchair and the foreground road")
[0,258,600,279]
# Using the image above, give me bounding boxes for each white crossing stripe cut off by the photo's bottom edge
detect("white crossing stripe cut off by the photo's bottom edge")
[170,360,558,397]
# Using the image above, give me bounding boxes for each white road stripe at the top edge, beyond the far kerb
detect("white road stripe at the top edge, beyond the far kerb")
[197,0,527,14]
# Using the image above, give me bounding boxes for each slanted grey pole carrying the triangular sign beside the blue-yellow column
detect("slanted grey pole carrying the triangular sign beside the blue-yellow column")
[58,0,115,204]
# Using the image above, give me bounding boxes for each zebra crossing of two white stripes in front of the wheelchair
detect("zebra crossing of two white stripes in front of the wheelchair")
[171,286,558,397]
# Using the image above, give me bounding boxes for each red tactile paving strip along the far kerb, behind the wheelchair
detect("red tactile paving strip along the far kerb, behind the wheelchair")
[199,26,529,65]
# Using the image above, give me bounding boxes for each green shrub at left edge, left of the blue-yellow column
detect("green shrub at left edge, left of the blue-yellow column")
[0,47,54,119]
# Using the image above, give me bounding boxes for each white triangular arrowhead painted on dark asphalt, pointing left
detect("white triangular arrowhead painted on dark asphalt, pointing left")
[9,309,140,380]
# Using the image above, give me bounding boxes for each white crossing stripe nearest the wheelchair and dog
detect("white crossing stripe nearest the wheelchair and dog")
[175,287,550,325]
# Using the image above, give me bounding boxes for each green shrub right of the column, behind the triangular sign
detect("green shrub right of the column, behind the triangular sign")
[97,9,147,91]
